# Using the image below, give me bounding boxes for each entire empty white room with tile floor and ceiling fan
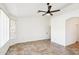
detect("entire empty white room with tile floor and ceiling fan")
[0,3,79,55]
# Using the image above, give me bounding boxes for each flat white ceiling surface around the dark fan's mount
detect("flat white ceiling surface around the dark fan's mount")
[4,3,68,17]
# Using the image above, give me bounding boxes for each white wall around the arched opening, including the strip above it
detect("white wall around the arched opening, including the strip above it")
[51,9,79,46]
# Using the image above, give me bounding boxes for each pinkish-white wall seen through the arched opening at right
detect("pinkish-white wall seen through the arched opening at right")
[66,17,79,45]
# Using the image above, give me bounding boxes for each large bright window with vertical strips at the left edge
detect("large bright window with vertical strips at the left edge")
[0,9,9,47]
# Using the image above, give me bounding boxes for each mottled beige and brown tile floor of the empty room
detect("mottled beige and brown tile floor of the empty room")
[6,39,79,55]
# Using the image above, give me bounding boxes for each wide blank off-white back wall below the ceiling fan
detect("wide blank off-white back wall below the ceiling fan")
[14,16,50,42]
